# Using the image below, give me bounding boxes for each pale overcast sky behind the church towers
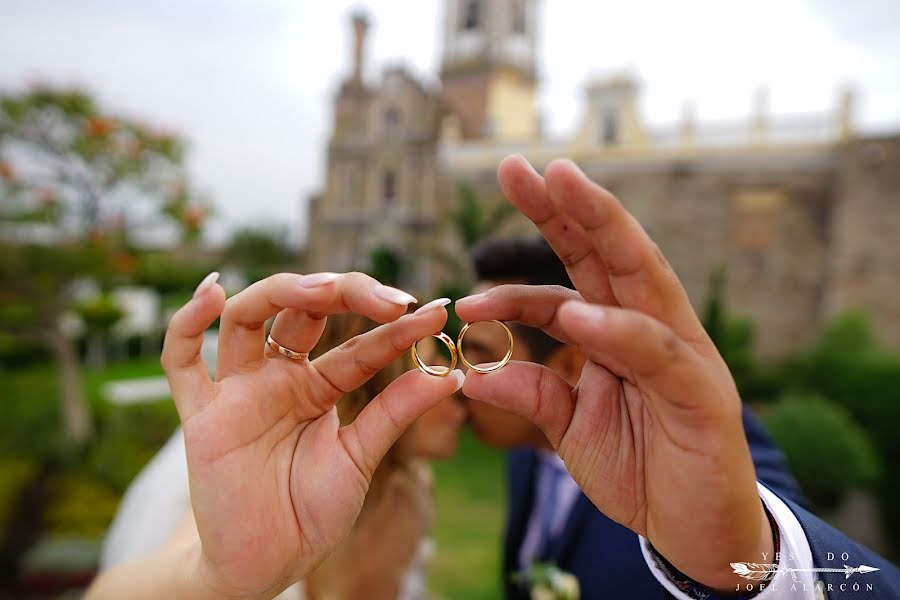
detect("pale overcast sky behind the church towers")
[0,0,900,246]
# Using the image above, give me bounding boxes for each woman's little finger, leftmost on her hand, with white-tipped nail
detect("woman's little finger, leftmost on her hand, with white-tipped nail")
[160,273,225,422]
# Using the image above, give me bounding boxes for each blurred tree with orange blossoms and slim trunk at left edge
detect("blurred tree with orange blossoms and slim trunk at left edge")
[0,85,207,443]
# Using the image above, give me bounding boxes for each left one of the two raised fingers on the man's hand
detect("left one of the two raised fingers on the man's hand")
[497,155,616,304]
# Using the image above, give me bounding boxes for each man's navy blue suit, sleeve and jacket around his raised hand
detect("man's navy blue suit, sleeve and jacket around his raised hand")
[503,407,900,600]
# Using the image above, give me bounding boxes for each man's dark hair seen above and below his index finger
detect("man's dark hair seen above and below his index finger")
[472,237,575,362]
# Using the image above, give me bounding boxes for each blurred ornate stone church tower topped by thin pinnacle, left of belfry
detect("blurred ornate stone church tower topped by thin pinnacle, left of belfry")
[307,13,442,290]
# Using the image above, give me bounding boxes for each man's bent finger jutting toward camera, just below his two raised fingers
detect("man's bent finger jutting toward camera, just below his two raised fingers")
[559,302,720,408]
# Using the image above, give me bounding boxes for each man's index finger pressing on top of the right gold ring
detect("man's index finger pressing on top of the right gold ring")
[454,285,582,344]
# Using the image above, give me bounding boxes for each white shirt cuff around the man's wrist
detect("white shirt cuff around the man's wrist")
[638,481,816,600]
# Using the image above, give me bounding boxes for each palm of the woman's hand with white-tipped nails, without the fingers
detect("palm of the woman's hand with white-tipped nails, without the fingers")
[184,363,352,593]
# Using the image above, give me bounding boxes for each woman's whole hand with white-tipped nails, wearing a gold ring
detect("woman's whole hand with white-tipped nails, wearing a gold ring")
[162,273,461,598]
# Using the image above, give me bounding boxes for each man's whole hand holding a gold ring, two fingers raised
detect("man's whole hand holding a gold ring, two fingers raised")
[456,157,773,590]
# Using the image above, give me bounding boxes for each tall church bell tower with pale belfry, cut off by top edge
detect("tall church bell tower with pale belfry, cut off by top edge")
[440,0,539,141]
